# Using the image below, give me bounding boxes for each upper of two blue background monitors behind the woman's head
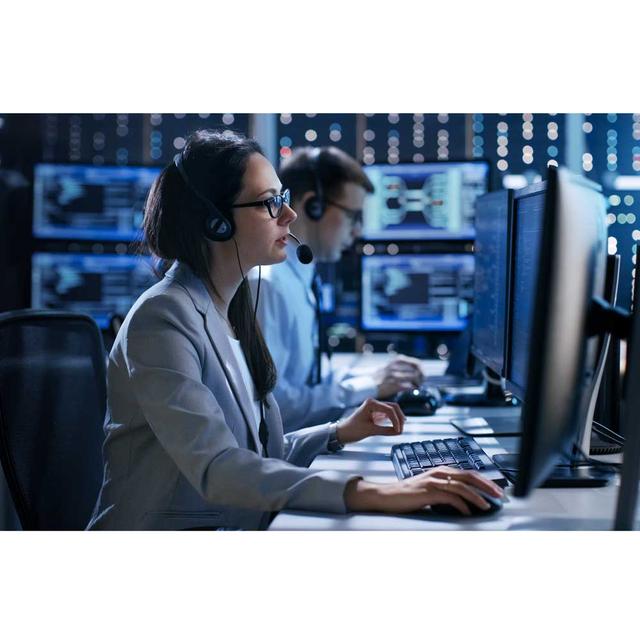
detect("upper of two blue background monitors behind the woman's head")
[33,164,160,242]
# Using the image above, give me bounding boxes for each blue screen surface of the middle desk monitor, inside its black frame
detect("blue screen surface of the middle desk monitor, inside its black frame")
[507,192,545,392]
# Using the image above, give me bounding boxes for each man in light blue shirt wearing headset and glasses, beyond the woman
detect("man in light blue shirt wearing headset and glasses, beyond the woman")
[250,147,422,432]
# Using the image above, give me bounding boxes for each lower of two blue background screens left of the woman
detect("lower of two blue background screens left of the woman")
[31,253,157,329]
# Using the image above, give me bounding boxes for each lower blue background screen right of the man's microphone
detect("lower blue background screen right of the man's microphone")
[361,253,473,331]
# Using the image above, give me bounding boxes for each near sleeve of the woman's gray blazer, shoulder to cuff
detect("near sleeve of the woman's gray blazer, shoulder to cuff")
[125,296,358,513]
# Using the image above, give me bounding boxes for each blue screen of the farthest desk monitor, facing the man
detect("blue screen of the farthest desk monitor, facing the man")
[471,190,512,376]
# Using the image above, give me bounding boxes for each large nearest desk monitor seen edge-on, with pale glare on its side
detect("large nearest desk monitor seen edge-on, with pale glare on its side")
[511,169,607,496]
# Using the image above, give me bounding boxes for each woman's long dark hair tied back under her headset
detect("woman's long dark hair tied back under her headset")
[143,129,276,400]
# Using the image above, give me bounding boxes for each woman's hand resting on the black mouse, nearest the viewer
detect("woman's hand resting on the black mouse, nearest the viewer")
[344,467,503,515]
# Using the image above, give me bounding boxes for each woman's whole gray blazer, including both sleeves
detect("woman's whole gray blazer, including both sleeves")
[88,263,357,529]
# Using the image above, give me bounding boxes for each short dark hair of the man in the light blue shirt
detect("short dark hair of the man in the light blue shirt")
[279,147,374,201]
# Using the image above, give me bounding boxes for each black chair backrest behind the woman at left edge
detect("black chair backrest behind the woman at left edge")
[0,310,106,530]
